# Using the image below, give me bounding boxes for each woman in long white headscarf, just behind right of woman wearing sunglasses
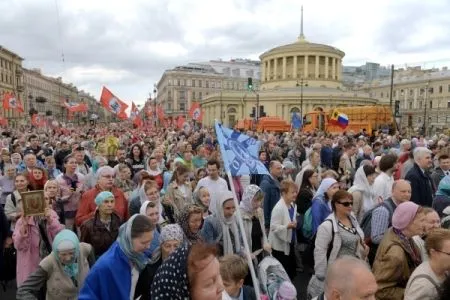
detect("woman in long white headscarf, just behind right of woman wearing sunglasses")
[348,160,378,222]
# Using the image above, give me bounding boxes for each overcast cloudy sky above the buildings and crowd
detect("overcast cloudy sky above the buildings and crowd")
[0,0,450,104]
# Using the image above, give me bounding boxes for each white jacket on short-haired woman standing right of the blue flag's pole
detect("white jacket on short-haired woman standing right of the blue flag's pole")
[269,198,297,255]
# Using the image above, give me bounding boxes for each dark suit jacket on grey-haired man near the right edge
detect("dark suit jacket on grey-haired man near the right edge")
[405,163,435,207]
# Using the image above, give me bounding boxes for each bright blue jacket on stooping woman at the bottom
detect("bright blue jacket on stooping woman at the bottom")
[78,241,131,300]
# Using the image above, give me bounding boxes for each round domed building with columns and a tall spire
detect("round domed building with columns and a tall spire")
[201,9,378,126]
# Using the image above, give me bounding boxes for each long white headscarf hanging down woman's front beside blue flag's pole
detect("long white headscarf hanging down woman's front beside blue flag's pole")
[216,191,241,255]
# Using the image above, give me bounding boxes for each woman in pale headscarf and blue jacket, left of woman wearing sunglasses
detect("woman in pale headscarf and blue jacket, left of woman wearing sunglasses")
[311,178,339,235]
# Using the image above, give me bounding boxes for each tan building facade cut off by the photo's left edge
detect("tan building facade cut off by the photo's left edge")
[0,46,24,127]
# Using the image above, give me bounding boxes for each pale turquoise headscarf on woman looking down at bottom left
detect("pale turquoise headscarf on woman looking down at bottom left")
[52,229,80,280]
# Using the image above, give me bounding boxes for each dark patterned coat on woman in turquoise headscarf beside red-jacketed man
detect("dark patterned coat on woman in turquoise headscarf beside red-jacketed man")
[80,211,121,257]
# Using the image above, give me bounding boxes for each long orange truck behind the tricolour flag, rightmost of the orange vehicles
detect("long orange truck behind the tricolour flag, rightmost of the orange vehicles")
[303,105,394,133]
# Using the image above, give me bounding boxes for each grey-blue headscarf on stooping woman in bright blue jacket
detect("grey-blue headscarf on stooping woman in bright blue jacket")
[117,214,149,272]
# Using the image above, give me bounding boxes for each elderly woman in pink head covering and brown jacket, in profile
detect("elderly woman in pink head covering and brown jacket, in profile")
[373,201,425,300]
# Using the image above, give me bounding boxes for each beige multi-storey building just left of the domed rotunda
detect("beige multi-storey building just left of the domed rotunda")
[156,60,259,116]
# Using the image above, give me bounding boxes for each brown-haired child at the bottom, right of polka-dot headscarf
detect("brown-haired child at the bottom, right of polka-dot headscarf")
[219,254,256,300]
